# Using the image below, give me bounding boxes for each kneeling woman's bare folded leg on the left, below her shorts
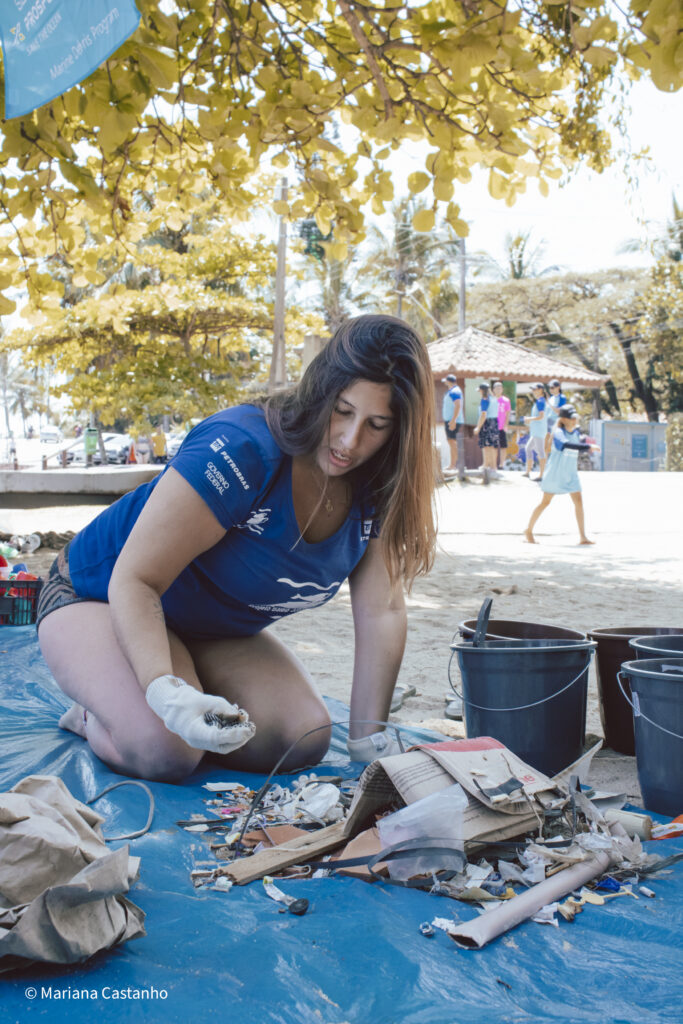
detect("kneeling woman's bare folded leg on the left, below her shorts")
[39,601,203,781]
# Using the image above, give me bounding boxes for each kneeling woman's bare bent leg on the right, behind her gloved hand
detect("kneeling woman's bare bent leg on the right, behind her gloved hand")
[187,631,330,772]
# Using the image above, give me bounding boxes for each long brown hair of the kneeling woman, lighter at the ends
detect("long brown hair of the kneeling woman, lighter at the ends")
[265,315,436,588]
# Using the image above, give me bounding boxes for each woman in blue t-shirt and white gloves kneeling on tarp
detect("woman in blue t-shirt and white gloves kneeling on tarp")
[37,315,435,781]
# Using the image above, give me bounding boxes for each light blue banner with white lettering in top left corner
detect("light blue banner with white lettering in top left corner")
[0,0,140,118]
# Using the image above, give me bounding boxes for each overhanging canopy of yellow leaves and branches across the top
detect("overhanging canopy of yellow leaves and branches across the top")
[0,0,683,313]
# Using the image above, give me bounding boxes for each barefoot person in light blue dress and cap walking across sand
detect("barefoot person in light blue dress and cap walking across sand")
[524,404,600,544]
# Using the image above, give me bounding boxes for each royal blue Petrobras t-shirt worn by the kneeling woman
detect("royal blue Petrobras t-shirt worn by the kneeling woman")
[69,406,376,639]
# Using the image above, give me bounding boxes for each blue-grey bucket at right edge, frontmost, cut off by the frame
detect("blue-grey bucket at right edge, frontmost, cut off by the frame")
[618,657,683,816]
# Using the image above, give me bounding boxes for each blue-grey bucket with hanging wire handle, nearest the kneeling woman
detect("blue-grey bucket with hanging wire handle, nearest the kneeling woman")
[451,639,595,775]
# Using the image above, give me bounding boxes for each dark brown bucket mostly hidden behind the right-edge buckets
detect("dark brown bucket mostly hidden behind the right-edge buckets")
[588,626,683,757]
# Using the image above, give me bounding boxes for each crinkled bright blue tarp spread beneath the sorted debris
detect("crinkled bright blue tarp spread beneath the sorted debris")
[0,627,683,1024]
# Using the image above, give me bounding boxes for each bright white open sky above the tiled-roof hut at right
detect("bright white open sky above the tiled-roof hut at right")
[395,81,683,271]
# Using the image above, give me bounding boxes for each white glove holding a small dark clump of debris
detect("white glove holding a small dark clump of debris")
[145,676,256,754]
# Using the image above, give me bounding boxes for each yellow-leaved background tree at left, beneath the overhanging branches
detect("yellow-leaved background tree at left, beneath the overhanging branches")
[0,180,319,426]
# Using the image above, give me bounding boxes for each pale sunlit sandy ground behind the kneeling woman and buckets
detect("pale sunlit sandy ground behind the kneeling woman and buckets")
[0,472,683,803]
